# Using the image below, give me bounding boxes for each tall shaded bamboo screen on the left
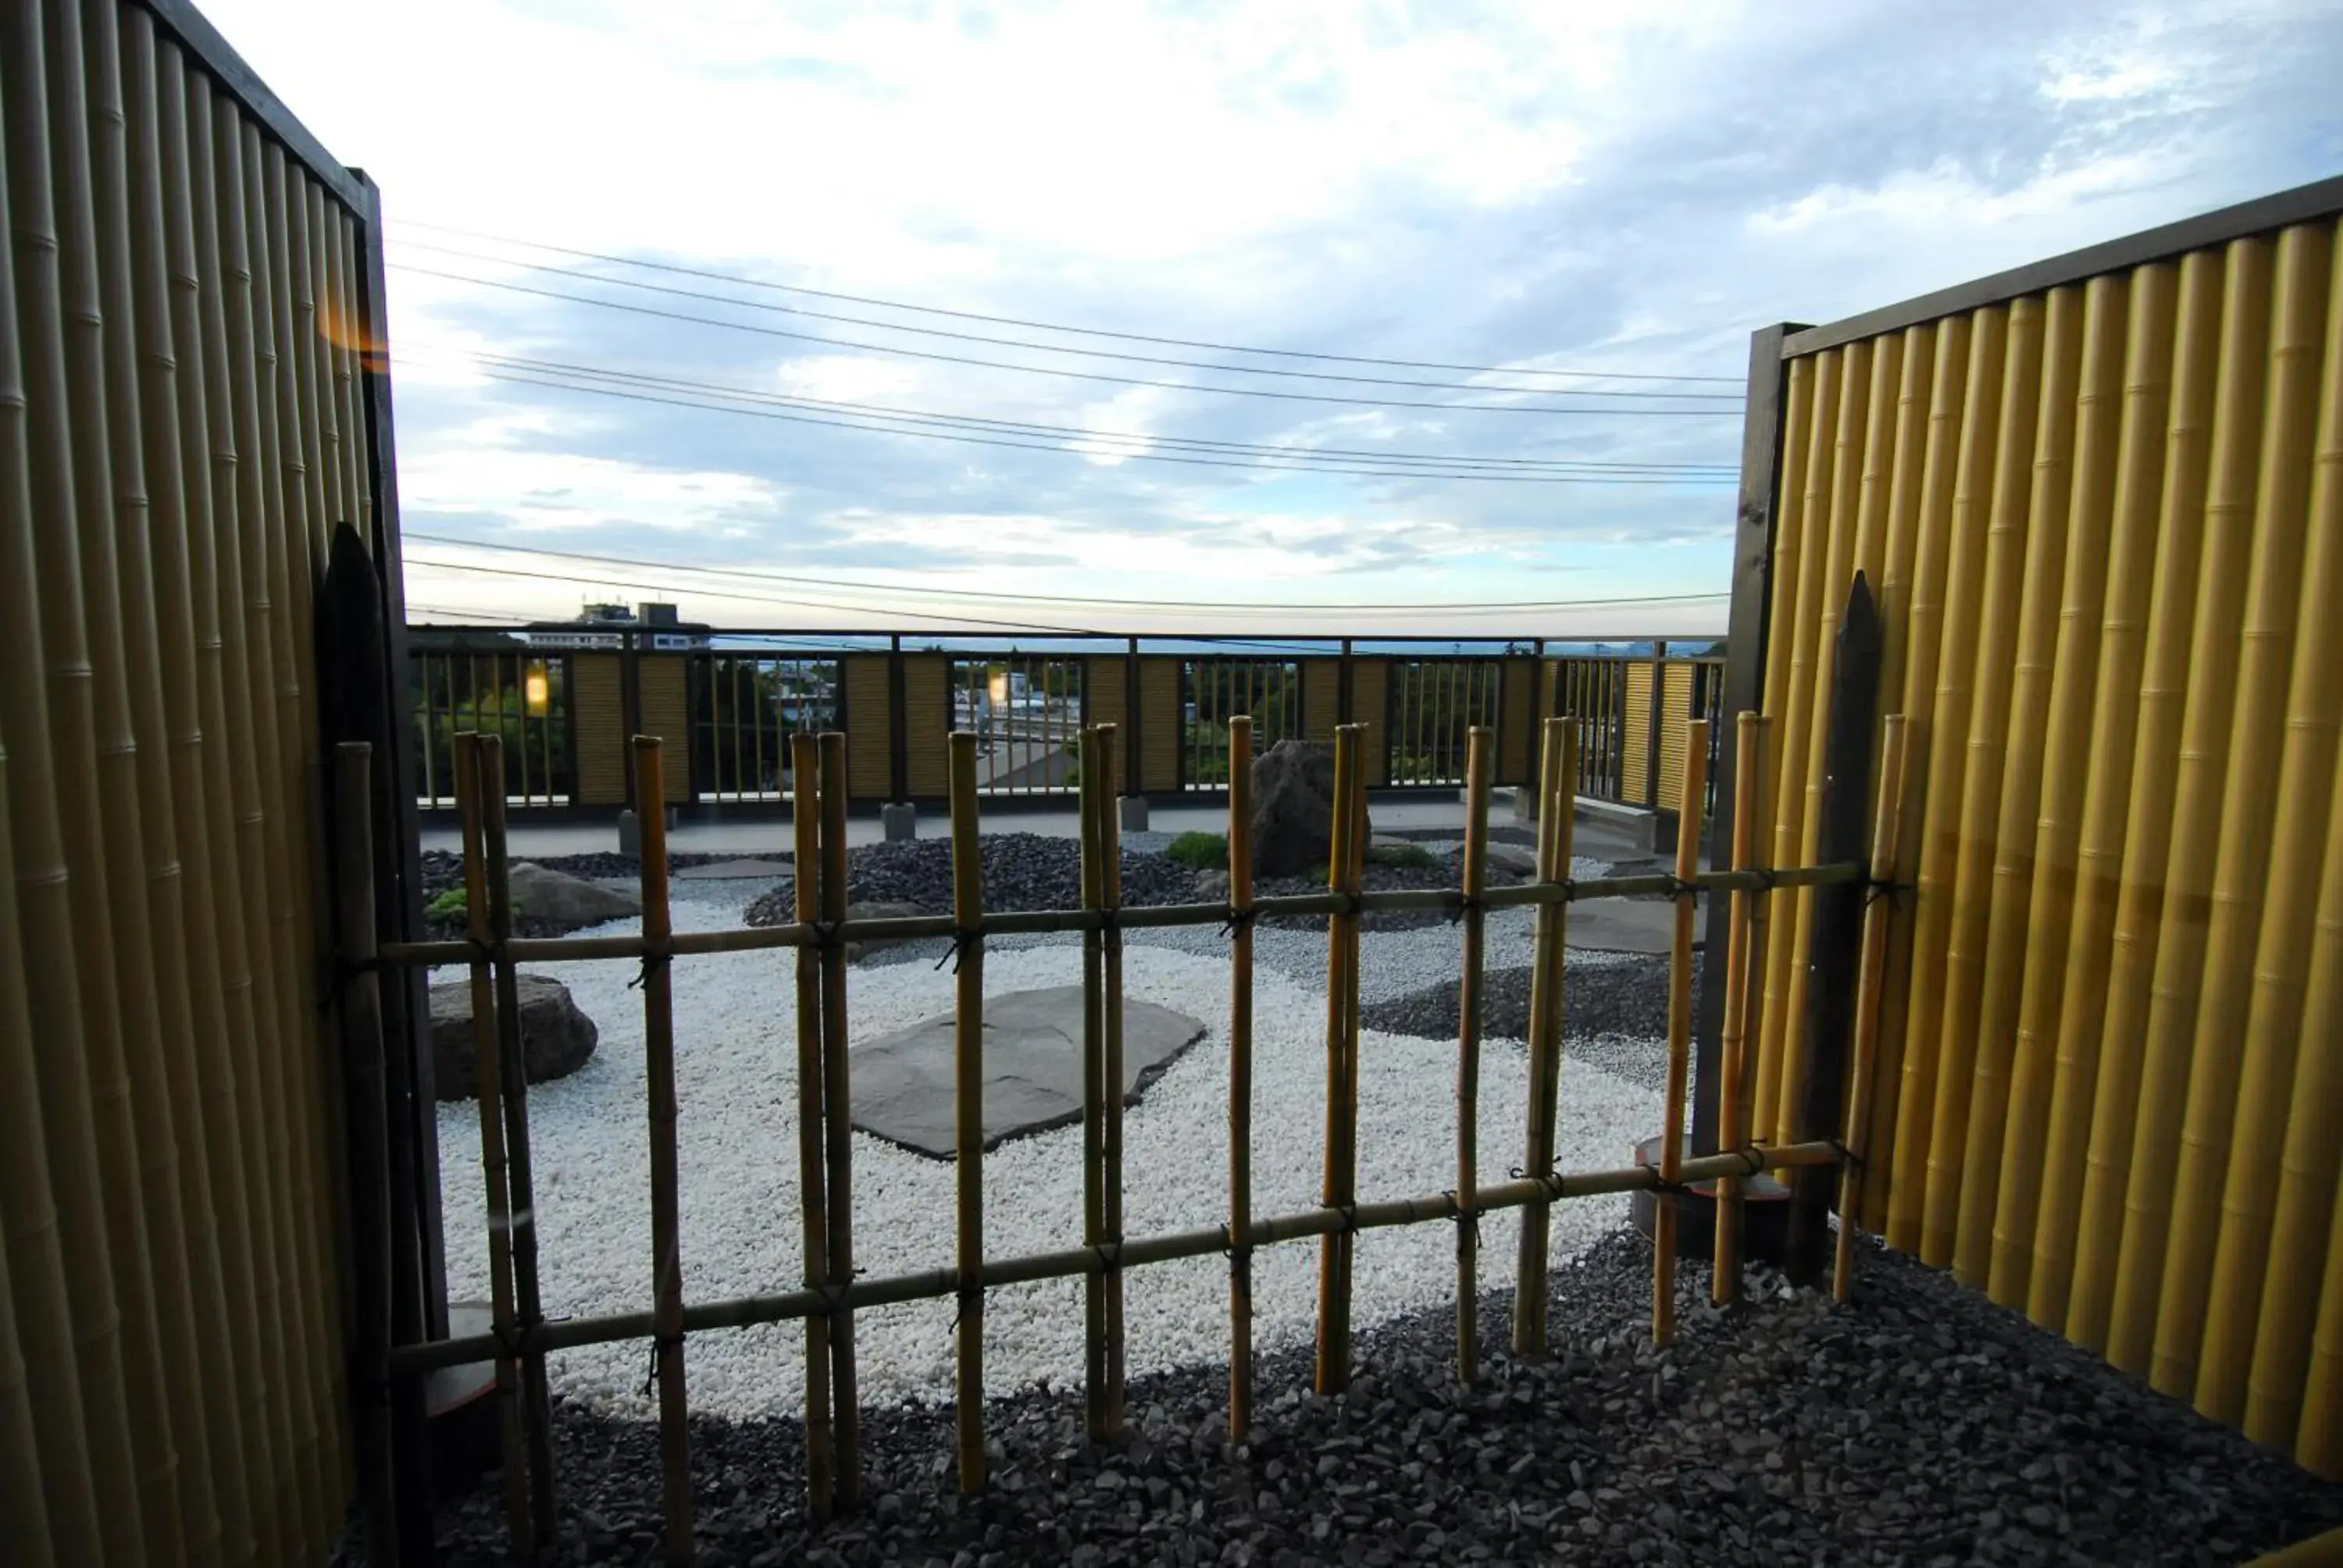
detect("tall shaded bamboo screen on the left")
[0,0,389,1566]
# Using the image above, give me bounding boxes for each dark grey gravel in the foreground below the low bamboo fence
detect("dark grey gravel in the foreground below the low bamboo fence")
[375,1231,2343,1568]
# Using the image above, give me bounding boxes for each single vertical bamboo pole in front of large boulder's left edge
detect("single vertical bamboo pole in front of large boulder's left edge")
[1228,717,1254,1444]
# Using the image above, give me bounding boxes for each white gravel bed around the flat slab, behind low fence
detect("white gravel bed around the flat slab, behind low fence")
[436,884,1659,1416]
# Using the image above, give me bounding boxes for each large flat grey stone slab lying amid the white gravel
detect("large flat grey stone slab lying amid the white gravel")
[848,985,1204,1160]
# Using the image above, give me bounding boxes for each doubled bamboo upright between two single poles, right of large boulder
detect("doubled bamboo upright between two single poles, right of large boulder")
[1514,719,1574,1357]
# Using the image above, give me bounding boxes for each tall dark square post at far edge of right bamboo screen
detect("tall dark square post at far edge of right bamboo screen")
[1692,323,1799,1153]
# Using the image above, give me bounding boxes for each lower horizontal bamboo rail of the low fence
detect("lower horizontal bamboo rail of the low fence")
[391,1139,1839,1376]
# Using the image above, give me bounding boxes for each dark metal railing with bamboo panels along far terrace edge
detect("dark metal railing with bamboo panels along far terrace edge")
[410,625,1724,811]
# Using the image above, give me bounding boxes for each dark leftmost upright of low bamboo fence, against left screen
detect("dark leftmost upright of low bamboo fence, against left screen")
[333,740,401,1563]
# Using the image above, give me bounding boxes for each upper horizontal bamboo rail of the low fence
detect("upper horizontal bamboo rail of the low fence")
[382,861,1865,966]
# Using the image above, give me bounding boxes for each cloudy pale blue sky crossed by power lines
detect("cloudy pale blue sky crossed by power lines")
[204,0,2343,635]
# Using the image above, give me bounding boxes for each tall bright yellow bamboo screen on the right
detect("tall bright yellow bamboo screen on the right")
[1757,205,2343,1477]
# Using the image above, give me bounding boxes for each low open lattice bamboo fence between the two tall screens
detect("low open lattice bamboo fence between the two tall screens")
[337,717,1900,1563]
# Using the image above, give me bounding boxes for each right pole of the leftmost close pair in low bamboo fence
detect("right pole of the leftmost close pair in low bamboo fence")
[473,736,553,1542]
